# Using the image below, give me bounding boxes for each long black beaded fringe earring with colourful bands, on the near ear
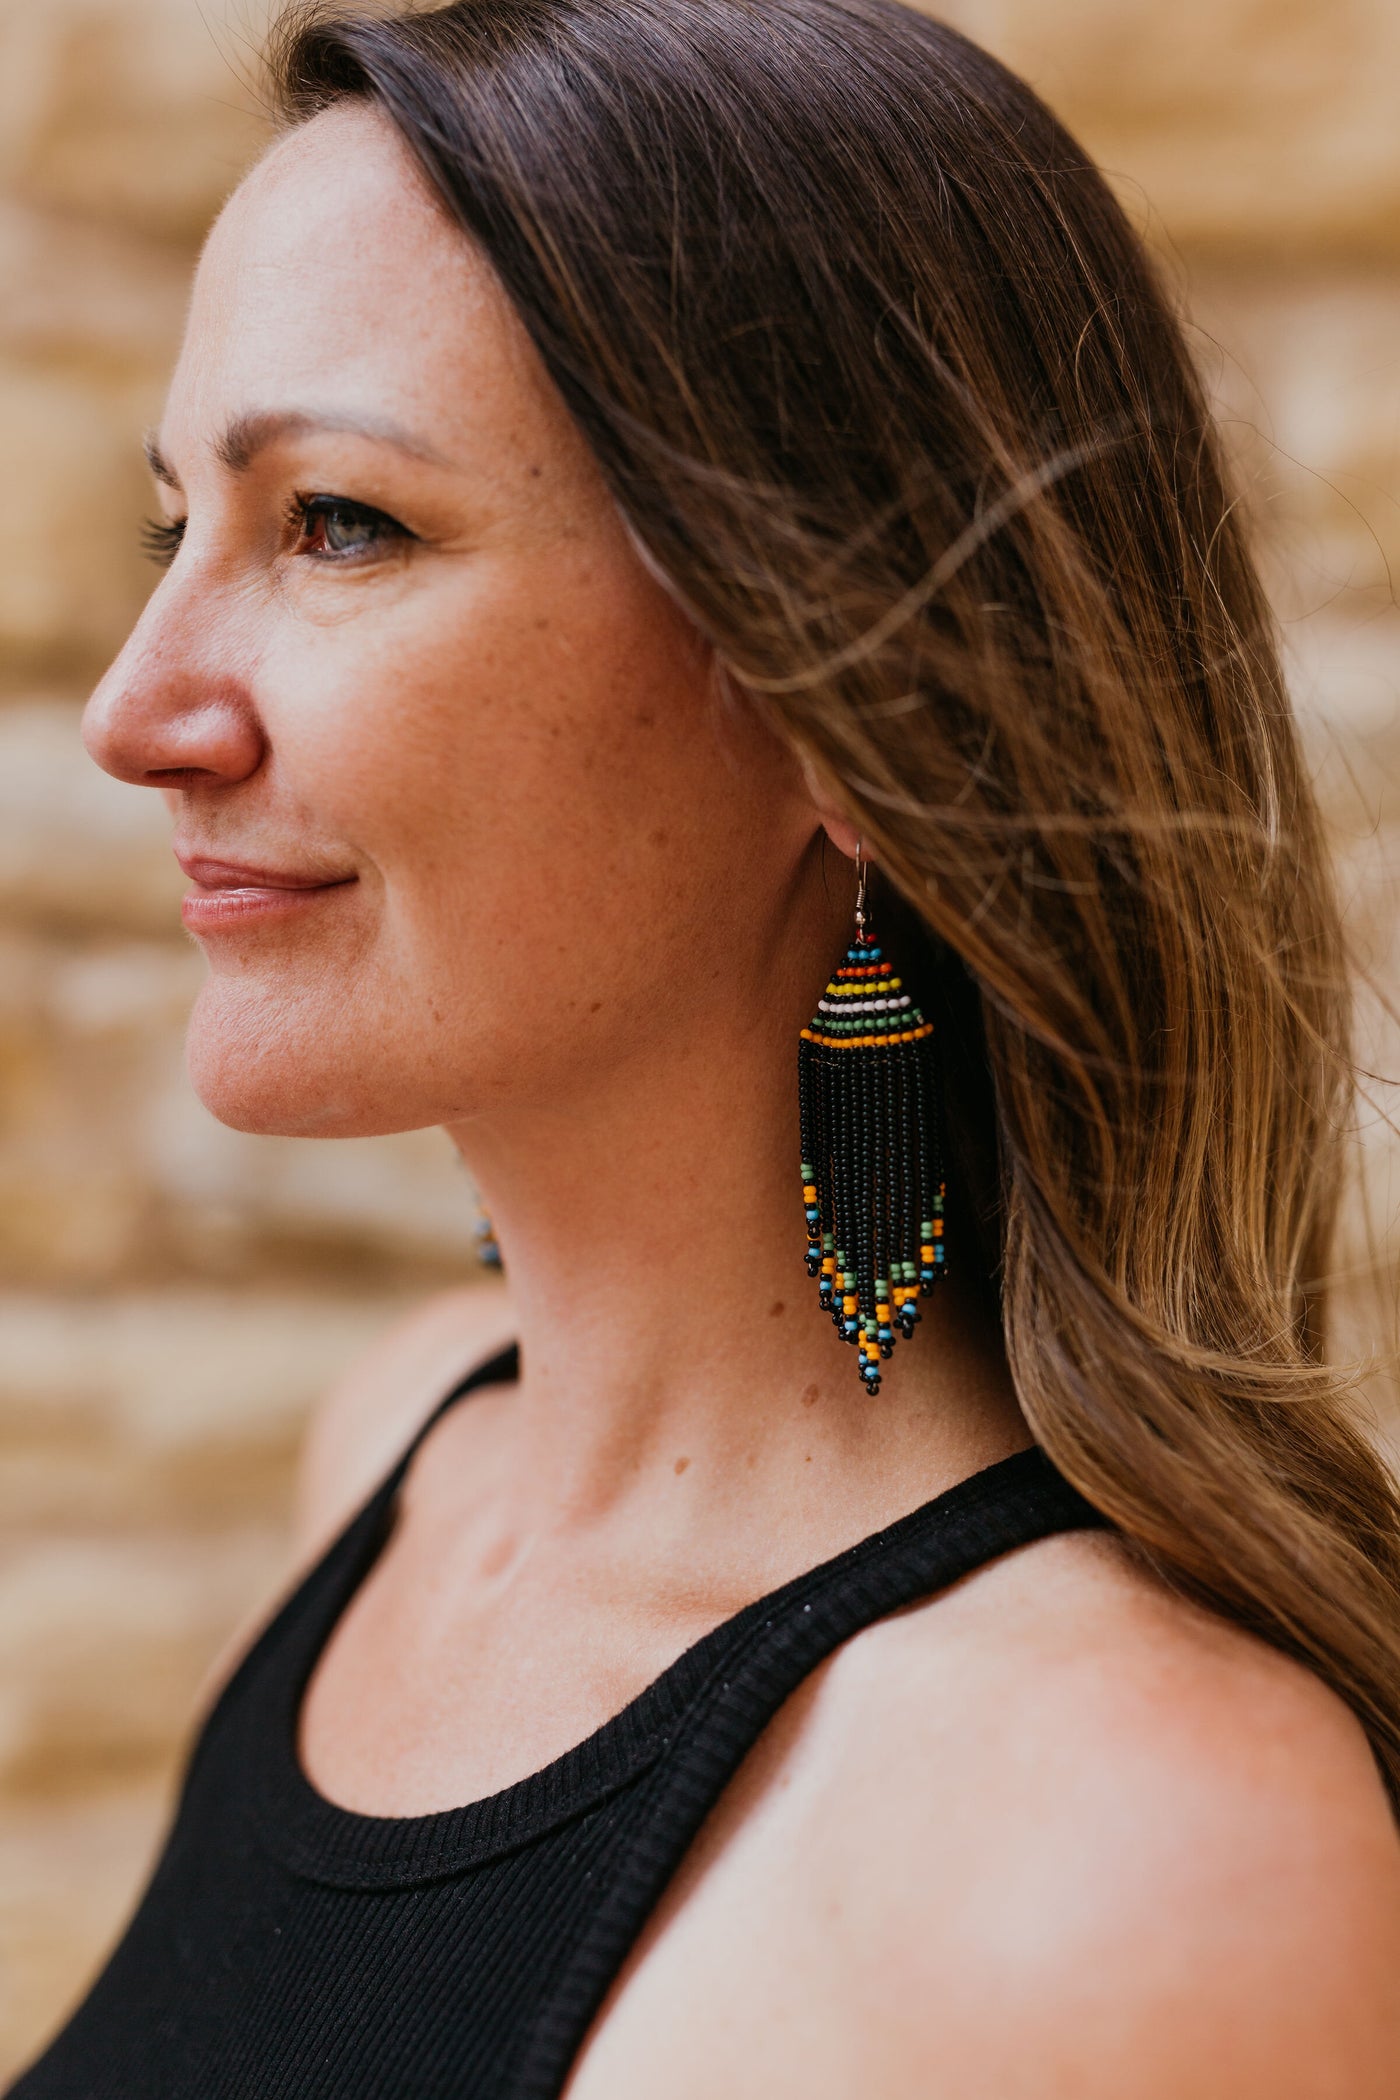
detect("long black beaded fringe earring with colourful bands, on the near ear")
[798,846,945,1392]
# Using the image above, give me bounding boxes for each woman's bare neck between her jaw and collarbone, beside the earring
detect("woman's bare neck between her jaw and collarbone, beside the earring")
[451,928,1028,1544]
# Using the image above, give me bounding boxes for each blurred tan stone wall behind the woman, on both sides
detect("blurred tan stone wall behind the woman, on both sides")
[0,0,1400,2077]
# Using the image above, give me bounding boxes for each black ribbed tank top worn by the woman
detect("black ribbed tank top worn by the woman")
[10,1348,1100,2100]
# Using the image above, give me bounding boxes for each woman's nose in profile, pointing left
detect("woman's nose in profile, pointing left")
[82,590,264,788]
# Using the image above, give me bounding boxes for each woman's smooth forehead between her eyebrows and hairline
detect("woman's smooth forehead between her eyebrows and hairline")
[166,103,545,451]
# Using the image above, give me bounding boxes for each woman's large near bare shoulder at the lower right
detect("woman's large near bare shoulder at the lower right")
[793,1533,1400,2100]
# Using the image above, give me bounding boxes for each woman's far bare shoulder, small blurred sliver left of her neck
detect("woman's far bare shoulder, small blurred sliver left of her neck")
[292,1277,514,1562]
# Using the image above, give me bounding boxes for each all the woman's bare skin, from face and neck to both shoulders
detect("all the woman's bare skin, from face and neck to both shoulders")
[86,105,1400,2100]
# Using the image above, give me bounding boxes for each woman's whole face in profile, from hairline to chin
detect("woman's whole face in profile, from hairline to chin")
[86,105,819,1136]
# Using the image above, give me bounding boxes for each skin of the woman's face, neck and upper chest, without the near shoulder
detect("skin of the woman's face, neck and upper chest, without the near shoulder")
[86,107,1026,1839]
